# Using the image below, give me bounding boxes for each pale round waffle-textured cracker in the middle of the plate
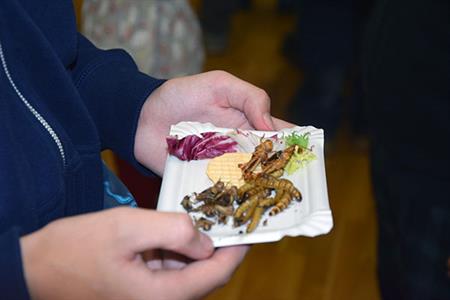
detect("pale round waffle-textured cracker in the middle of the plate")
[206,152,252,187]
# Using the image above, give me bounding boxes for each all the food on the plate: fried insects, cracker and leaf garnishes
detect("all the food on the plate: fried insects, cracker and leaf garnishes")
[171,129,316,233]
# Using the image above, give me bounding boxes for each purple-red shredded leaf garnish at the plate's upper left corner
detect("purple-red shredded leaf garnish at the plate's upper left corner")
[166,132,237,161]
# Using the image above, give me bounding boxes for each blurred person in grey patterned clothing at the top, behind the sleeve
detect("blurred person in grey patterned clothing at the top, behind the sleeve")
[82,0,204,78]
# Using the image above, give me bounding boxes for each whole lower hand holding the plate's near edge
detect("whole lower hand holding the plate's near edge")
[21,208,248,300]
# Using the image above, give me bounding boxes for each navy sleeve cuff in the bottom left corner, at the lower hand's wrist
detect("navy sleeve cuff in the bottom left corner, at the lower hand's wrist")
[0,227,30,300]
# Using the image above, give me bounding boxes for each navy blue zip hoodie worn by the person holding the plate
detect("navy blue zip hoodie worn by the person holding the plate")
[0,0,162,300]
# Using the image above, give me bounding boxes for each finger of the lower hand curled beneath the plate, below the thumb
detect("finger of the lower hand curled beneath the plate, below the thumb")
[154,246,249,299]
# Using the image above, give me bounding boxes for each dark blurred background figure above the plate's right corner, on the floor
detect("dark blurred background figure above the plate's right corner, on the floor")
[283,0,372,144]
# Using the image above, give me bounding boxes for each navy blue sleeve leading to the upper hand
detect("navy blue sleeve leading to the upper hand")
[71,34,164,173]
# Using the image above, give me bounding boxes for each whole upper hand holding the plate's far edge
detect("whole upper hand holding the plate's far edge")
[134,71,293,175]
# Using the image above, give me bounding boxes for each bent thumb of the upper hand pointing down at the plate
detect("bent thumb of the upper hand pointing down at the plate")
[223,74,275,131]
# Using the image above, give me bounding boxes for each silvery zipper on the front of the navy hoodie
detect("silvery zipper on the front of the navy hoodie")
[0,42,66,169]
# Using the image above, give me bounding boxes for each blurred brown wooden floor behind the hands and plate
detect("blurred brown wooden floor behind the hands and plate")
[200,1,379,300]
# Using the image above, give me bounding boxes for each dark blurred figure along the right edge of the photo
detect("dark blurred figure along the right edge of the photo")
[365,0,450,300]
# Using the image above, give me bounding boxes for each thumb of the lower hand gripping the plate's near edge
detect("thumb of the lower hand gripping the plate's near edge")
[115,208,214,259]
